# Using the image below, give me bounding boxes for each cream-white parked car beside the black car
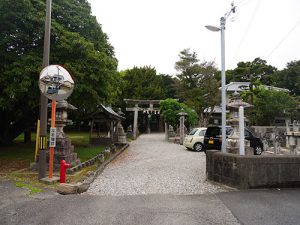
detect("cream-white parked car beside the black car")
[183,127,206,152]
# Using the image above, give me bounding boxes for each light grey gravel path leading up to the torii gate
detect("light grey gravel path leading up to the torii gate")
[87,134,228,196]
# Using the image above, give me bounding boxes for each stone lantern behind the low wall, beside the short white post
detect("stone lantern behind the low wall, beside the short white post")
[227,91,252,154]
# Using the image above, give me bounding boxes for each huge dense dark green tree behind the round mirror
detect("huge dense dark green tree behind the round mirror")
[0,0,117,145]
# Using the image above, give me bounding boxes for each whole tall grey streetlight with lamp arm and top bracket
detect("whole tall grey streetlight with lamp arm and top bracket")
[205,3,236,153]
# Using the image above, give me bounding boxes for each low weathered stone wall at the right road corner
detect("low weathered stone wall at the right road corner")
[206,150,300,189]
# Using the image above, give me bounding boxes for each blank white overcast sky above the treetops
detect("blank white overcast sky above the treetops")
[88,0,300,75]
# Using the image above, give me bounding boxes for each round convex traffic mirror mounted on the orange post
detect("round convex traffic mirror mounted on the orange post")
[39,65,74,101]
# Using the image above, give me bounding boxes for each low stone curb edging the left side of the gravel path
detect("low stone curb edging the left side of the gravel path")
[57,143,129,195]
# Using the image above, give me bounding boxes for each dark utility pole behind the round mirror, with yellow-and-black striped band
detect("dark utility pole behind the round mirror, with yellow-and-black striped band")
[39,0,52,180]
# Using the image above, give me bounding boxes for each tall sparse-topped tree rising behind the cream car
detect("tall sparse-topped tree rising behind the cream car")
[175,49,220,126]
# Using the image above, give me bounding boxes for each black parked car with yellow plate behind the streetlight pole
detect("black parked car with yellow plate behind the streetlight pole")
[204,126,264,155]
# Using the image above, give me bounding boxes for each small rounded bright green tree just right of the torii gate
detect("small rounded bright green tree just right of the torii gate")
[160,98,198,127]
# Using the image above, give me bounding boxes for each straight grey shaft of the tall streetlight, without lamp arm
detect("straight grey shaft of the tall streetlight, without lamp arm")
[220,17,226,153]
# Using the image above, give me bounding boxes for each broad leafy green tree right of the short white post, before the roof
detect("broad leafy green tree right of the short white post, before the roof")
[243,86,299,125]
